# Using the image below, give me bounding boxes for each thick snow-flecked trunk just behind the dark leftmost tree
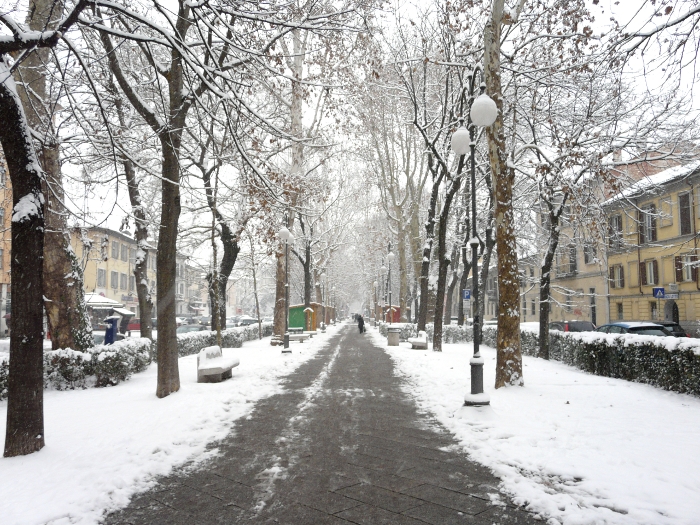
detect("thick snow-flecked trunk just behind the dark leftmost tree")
[18,0,94,350]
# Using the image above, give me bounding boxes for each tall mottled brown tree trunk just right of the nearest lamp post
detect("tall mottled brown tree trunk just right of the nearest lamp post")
[484,0,524,388]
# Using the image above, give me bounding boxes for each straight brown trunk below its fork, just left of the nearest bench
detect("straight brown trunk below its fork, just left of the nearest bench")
[156,139,180,398]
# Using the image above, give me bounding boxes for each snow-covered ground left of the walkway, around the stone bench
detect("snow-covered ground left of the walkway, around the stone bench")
[0,327,336,525]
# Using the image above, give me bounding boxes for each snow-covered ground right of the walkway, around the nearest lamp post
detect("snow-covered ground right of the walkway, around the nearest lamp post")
[372,330,700,525]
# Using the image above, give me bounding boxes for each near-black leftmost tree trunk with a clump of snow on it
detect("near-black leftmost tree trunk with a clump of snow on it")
[0,56,45,457]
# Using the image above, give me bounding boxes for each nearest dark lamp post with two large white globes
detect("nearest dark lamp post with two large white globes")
[451,66,498,406]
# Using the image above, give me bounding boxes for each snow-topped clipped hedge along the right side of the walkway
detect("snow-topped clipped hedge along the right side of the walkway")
[379,323,700,396]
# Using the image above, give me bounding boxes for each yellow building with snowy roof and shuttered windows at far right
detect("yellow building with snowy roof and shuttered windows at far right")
[606,161,700,331]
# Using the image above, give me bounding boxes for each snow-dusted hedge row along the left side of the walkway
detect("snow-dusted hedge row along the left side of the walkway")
[0,323,272,400]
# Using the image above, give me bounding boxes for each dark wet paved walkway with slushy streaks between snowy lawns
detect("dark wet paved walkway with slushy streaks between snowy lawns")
[104,326,541,525]
